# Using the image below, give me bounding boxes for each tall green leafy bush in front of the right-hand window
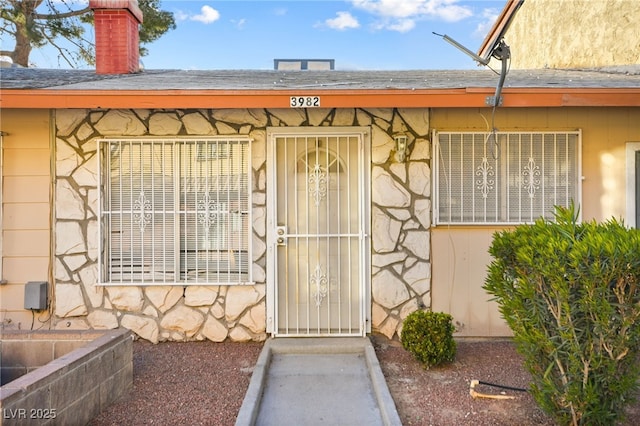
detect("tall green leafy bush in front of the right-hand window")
[484,206,640,425]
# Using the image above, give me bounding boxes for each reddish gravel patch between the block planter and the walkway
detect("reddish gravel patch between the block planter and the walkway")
[91,340,262,426]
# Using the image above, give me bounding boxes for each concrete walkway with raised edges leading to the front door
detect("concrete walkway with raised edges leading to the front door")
[236,337,401,426]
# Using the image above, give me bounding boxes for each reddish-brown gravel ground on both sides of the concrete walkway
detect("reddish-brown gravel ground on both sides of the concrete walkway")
[91,336,640,426]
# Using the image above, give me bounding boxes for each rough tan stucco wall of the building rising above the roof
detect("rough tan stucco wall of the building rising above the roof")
[505,0,640,69]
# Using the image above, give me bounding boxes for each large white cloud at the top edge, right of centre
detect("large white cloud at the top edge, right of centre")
[351,0,472,32]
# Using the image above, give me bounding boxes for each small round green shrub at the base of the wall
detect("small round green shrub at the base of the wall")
[401,311,456,367]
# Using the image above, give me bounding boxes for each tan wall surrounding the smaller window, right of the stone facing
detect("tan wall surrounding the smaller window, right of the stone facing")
[431,108,640,336]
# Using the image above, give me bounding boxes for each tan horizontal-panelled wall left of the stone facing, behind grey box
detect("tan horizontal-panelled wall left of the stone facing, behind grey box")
[0,109,51,329]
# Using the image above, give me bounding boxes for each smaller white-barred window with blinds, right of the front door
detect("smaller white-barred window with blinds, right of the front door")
[433,131,581,224]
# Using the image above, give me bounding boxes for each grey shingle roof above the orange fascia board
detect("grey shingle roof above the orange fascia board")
[0,66,640,91]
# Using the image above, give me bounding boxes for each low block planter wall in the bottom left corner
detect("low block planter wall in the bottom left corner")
[0,329,133,426]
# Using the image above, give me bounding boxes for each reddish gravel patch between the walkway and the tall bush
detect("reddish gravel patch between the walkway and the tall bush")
[372,336,553,426]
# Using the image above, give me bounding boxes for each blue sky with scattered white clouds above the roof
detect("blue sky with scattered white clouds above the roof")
[31,0,505,70]
